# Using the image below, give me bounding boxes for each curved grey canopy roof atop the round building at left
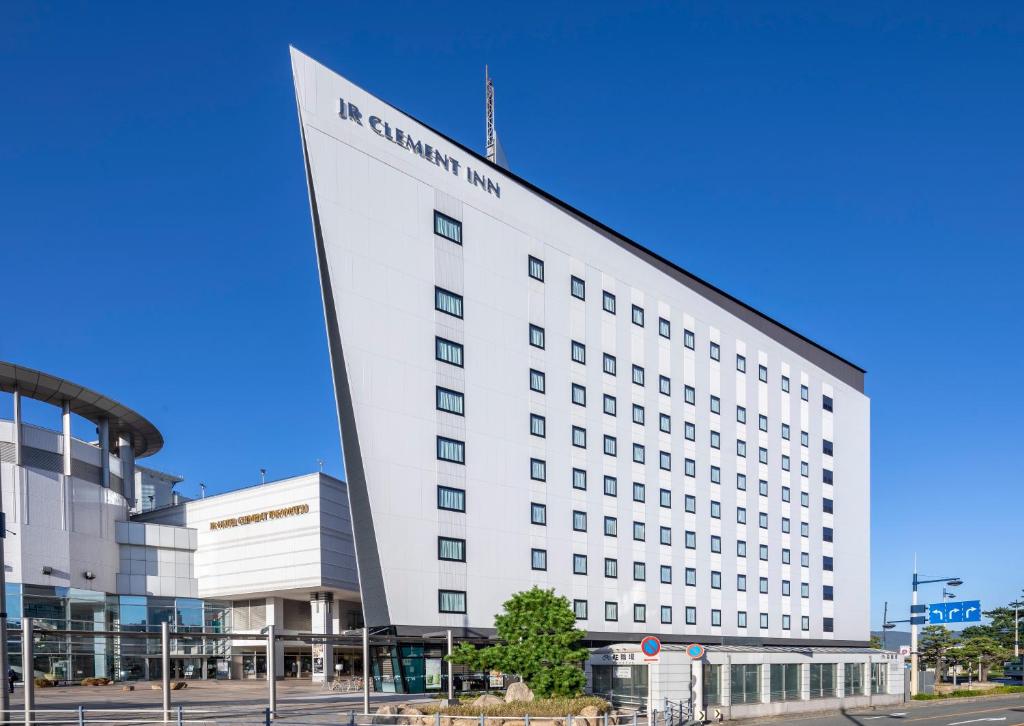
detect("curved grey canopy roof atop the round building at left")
[0,360,164,458]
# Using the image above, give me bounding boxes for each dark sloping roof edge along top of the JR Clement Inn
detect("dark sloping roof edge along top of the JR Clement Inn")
[292,46,866,393]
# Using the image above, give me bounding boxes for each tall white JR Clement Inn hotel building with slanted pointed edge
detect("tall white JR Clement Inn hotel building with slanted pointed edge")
[292,49,902,708]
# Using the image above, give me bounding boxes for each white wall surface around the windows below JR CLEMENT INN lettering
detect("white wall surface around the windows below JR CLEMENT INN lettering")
[292,51,869,642]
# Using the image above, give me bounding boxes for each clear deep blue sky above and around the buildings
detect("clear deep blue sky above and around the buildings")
[0,1,1024,625]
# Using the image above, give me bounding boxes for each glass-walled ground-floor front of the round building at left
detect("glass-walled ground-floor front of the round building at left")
[6,583,230,683]
